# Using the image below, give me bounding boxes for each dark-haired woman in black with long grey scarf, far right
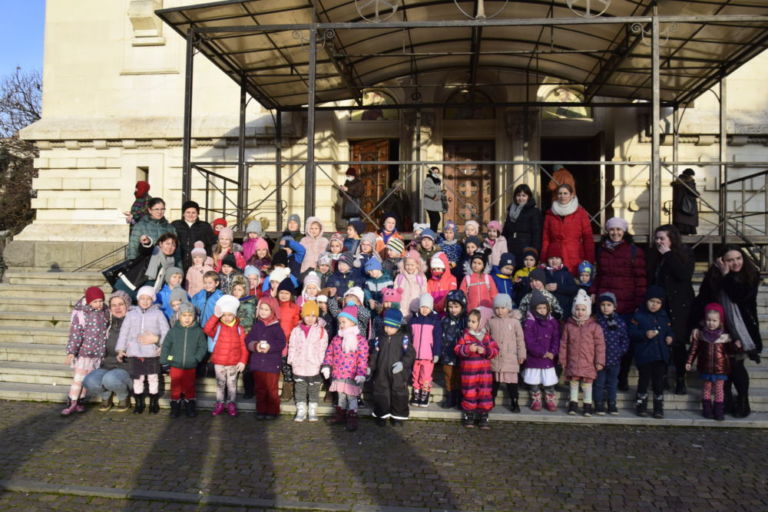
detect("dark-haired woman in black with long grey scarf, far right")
[696,246,763,417]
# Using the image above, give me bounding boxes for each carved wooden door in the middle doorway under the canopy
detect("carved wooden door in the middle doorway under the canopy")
[443,141,495,231]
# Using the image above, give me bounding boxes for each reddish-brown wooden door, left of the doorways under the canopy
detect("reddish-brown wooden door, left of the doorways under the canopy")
[350,139,389,231]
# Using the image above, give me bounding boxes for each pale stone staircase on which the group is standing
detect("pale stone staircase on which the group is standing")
[0,270,768,428]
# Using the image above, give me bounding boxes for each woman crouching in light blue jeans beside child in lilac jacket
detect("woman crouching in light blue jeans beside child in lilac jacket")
[83,290,137,412]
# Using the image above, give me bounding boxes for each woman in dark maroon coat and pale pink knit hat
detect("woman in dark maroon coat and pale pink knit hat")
[589,217,647,391]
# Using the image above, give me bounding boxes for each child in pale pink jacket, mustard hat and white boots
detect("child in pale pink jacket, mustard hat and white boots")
[288,302,328,422]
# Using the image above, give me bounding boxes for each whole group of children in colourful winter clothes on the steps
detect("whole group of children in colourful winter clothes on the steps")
[67,215,732,431]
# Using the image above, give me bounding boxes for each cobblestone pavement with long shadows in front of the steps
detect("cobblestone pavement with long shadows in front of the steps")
[0,401,768,512]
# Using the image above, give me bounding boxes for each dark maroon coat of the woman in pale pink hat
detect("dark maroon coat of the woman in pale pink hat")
[589,241,647,315]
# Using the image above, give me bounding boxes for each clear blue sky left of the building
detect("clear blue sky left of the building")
[0,0,45,77]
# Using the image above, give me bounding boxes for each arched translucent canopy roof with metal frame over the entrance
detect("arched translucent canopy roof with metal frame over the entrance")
[157,0,768,109]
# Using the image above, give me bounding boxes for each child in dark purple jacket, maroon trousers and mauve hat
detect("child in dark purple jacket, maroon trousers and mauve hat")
[245,295,285,420]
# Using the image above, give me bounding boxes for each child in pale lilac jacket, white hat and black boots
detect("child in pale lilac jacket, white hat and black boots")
[115,286,168,414]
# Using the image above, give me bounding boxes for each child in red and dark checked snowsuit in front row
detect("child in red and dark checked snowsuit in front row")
[453,309,499,430]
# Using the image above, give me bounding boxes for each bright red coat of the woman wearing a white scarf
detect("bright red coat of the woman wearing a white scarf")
[541,206,595,274]
